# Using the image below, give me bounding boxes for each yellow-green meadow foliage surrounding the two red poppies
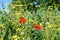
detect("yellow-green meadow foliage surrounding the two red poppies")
[0,0,60,40]
